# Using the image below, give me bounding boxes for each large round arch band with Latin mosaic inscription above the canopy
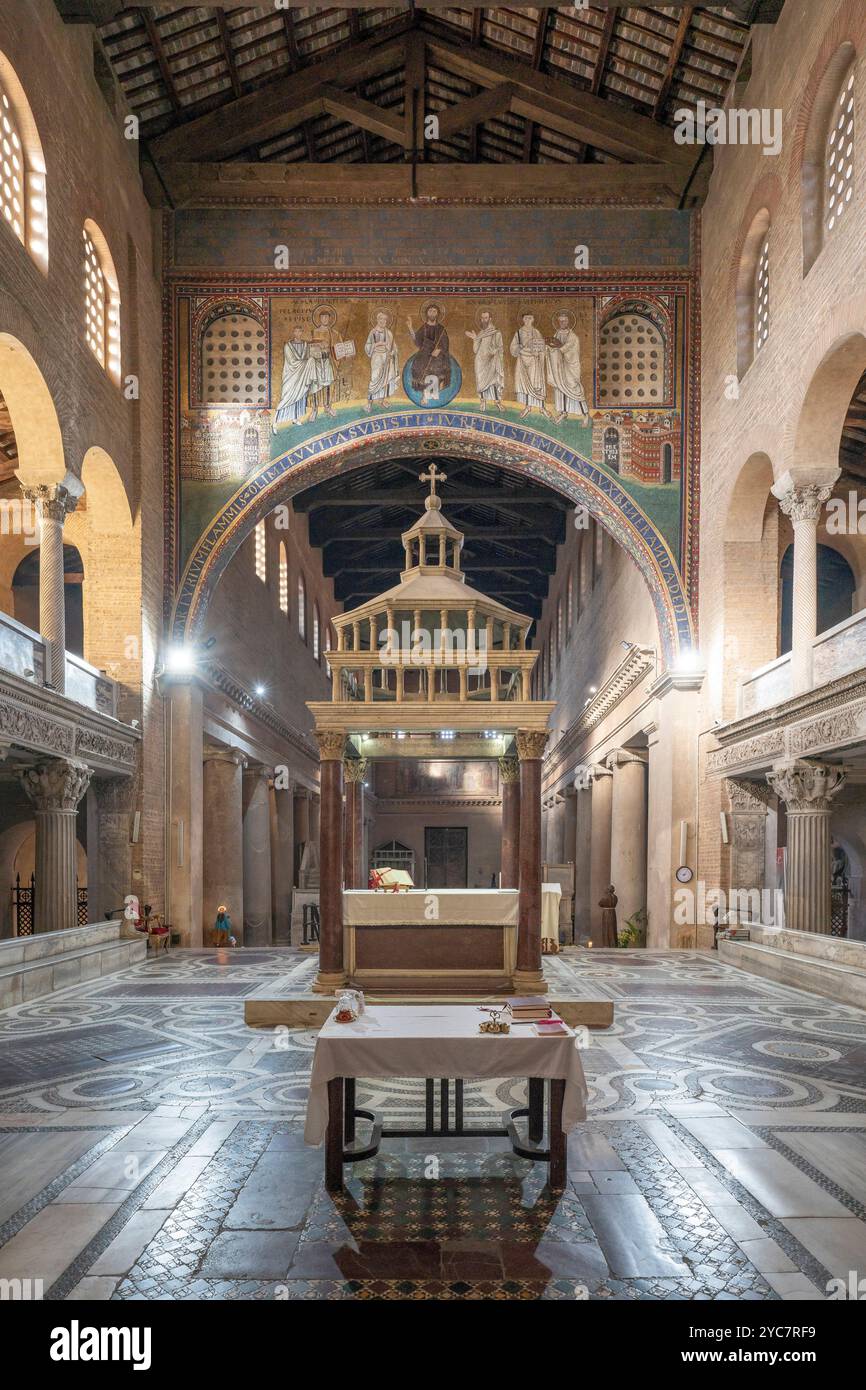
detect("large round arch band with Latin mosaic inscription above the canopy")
[171,411,694,664]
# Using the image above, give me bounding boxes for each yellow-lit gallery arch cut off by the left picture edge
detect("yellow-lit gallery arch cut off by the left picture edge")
[0,334,67,487]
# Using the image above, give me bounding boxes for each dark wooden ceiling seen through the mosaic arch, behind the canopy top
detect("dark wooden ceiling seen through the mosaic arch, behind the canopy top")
[293,459,570,617]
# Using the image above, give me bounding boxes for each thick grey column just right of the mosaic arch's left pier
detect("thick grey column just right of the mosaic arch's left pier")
[202,744,246,945]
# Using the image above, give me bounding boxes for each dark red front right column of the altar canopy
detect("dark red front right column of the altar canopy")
[514,728,548,994]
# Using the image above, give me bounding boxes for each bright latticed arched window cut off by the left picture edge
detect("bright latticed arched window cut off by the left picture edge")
[0,53,49,271]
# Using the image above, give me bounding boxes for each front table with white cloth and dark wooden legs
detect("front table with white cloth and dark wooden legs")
[304,1004,587,1191]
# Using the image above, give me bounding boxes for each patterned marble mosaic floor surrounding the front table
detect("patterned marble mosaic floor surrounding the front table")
[0,949,866,1300]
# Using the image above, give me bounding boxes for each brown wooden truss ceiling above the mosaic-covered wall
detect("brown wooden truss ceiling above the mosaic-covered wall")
[84,0,778,202]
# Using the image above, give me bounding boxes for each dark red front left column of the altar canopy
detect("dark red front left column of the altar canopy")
[313,728,346,994]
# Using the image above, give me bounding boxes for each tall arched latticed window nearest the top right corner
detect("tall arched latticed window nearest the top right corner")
[802,43,855,275]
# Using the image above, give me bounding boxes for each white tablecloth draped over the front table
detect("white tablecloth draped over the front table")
[304,1004,587,1144]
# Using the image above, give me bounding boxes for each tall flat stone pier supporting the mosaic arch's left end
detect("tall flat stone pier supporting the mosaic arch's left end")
[161,676,202,947]
